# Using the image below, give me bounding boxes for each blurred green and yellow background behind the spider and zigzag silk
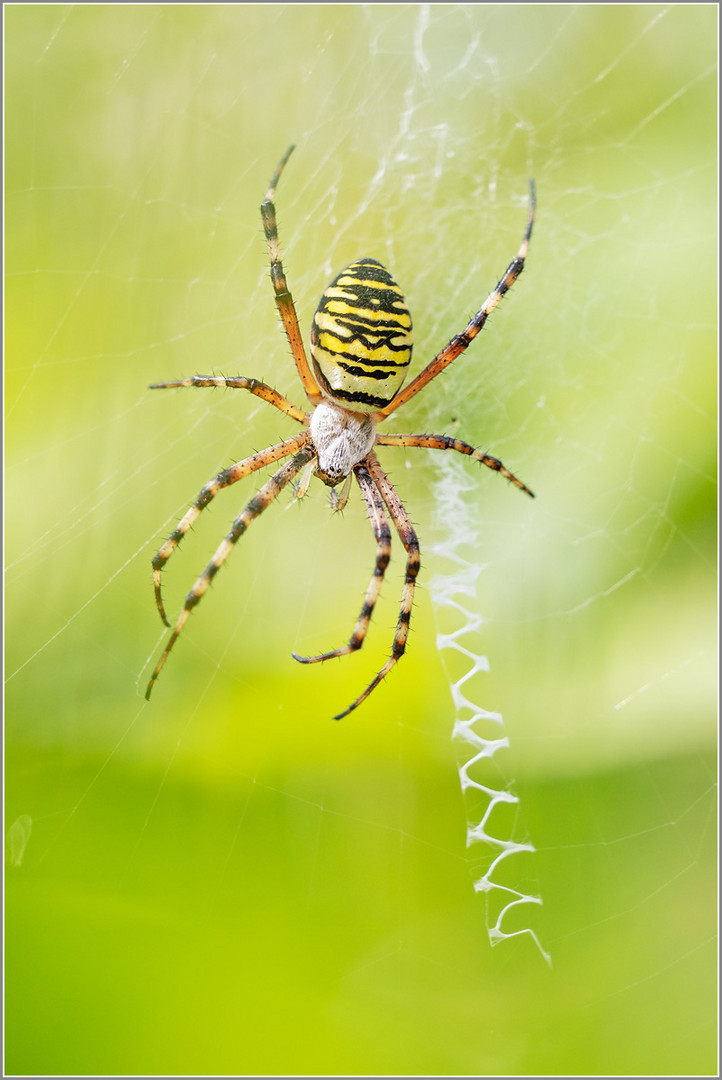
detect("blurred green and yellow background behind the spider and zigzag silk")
[4,4,717,1075]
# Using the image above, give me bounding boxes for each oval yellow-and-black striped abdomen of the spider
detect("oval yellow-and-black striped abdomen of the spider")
[311,259,413,413]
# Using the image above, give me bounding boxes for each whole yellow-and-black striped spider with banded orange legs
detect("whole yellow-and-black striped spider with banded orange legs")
[146,146,535,720]
